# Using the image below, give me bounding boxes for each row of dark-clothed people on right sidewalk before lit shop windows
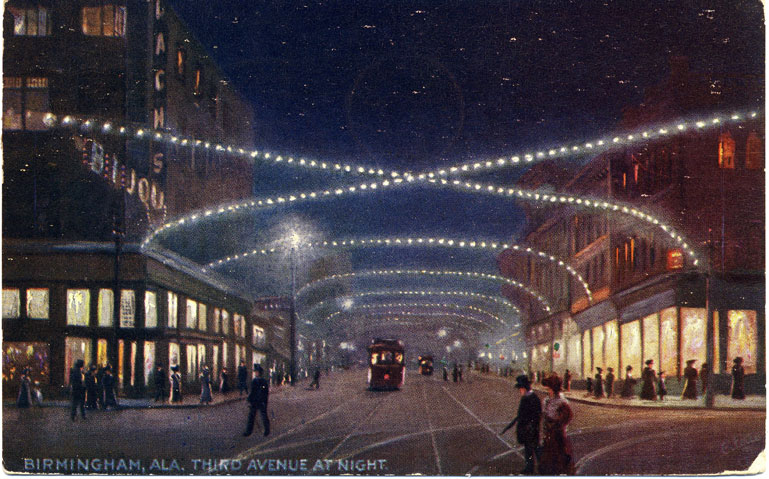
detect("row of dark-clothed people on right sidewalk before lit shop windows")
[584,357,745,401]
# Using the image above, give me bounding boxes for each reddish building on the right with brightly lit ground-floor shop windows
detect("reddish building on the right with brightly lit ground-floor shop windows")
[499,58,766,392]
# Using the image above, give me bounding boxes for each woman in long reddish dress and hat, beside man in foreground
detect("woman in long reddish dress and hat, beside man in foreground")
[539,373,575,476]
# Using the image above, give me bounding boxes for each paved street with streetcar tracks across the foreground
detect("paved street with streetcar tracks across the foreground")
[3,370,765,475]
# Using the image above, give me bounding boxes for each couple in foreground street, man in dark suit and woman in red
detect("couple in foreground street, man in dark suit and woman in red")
[500,373,575,476]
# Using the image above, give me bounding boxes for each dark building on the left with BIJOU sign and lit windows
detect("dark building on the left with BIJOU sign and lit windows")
[2,0,272,394]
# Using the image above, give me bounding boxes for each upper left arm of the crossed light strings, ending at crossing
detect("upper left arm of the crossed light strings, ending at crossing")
[43,113,408,182]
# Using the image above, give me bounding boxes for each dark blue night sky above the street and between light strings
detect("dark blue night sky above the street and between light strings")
[162,0,764,352]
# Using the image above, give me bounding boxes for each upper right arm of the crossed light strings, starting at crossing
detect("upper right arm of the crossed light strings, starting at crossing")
[424,111,759,179]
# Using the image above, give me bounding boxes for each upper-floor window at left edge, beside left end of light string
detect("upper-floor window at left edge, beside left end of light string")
[3,77,51,130]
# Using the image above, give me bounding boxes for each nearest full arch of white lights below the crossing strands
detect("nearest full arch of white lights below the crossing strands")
[206,237,593,303]
